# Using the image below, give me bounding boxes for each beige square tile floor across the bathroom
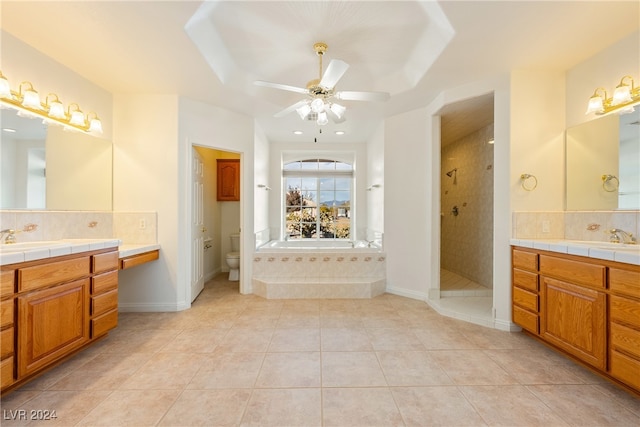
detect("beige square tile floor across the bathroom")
[1,276,640,426]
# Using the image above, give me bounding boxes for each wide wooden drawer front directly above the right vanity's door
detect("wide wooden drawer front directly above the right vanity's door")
[540,255,606,288]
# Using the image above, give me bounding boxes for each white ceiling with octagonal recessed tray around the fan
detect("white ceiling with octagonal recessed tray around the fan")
[0,0,640,143]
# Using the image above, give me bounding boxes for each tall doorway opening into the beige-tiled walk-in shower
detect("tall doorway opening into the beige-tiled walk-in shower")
[440,94,494,318]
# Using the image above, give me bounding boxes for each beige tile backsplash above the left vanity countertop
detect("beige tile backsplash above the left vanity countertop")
[0,210,157,244]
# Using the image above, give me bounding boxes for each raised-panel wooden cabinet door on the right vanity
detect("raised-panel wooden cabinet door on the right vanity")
[541,277,607,370]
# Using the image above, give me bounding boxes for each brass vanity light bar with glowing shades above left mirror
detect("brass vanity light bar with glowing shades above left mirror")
[0,71,102,134]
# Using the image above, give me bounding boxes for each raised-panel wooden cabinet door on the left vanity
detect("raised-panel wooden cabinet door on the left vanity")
[17,278,89,378]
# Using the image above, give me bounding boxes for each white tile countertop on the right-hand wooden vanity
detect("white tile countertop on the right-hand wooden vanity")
[510,239,640,265]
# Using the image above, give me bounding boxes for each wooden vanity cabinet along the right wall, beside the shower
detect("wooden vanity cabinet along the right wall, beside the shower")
[512,247,640,392]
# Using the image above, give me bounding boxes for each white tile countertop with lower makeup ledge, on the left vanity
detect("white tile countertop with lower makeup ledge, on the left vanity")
[0,239,160,265]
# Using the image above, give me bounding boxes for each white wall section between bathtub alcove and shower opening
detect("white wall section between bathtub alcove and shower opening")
[383,108,432,300]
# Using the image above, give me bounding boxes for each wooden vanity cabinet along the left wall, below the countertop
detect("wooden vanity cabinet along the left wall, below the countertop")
[0,248,118,392]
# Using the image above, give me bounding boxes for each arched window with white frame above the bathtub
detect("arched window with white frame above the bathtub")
[282,159,353,239]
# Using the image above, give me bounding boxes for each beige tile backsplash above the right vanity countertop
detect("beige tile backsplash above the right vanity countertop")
[511,210,640,241]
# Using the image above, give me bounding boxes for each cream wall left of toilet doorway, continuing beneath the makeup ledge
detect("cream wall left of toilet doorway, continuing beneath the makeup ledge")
[113,95,181,311]
